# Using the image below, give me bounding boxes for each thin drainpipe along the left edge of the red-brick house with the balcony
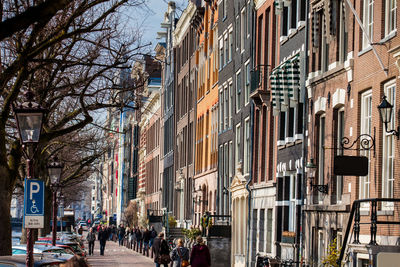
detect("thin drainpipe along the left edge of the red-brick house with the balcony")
[246,1,255,267]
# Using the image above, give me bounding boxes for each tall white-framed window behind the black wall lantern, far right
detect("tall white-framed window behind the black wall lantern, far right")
[382,80,396,201]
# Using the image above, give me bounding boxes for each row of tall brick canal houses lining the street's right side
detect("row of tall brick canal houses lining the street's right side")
[100,0,400,266]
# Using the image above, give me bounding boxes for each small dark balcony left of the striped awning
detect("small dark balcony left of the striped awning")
[250,65,271,105]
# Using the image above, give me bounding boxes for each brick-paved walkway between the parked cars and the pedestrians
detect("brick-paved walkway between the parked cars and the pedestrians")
[85,241,155,267]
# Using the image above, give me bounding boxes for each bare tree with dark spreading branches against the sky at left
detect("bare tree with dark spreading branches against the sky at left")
[0,0,151,255]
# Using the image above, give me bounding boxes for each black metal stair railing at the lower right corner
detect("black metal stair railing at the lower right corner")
[337,198,400,266]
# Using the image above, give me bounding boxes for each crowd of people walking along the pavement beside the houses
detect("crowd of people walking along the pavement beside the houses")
[86,224,211,267]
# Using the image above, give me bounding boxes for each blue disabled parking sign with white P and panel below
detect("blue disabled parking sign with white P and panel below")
[24,179,44,228]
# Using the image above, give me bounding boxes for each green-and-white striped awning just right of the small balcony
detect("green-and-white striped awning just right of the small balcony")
[270,55,300,115]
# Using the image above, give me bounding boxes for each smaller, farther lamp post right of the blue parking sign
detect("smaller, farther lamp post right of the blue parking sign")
[47,157,64,246]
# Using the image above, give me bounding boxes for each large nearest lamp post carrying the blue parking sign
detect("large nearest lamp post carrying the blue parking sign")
[13,90,47,267]
